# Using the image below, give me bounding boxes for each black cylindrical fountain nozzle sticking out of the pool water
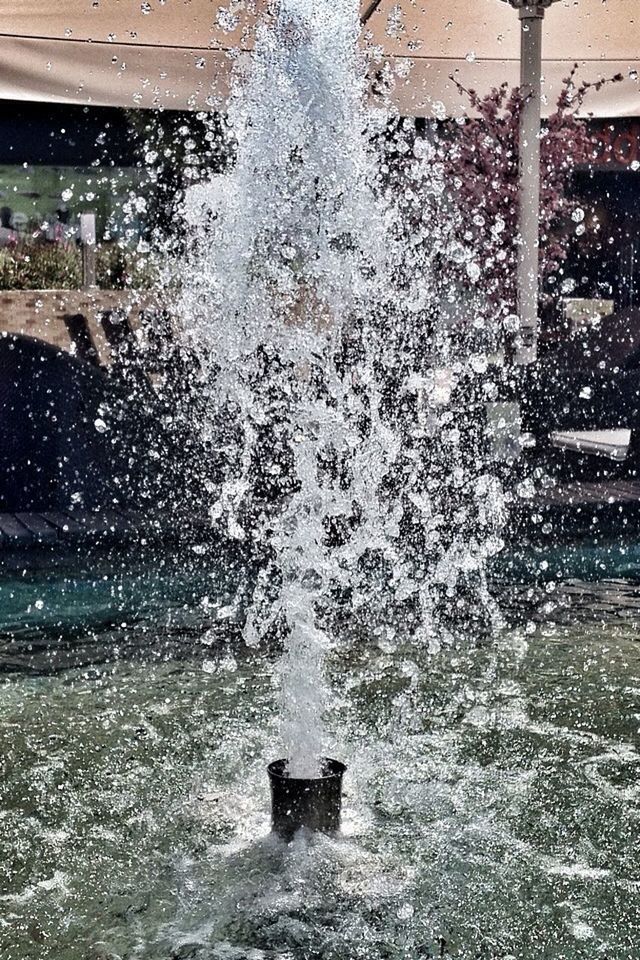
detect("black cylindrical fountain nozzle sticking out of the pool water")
[267,757,347,841]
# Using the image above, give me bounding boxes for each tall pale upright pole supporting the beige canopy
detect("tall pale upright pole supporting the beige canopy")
[513,3,544,364]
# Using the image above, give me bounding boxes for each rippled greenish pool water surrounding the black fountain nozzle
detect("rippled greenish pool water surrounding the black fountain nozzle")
[0,570,640,960]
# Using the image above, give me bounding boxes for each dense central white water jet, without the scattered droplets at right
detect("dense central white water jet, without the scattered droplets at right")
[182,0,384,776]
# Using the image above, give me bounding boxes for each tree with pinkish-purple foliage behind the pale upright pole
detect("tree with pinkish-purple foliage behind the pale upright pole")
[444,67,622,319]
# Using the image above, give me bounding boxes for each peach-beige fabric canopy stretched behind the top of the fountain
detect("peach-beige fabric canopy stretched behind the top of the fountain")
[0,0,640,118]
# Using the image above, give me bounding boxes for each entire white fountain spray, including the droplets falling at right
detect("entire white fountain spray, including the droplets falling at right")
[182,0,501,776]
